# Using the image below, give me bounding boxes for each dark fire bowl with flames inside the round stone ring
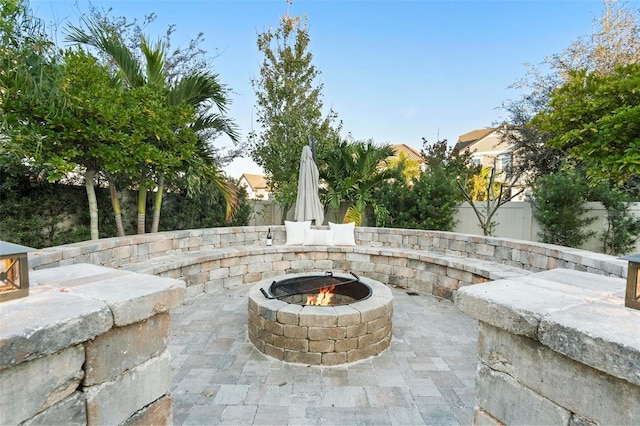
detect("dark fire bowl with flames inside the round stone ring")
[262,272,371,306]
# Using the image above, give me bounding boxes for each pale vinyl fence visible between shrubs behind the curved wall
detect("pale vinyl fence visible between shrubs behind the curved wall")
[249,200,640,253]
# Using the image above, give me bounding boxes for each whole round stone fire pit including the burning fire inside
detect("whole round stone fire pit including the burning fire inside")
[248,272,393,365]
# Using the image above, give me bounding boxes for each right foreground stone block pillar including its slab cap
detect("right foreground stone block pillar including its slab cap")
[456,269,640,425]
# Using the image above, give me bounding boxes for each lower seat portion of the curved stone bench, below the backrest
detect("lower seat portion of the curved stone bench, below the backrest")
[111,245,529,299]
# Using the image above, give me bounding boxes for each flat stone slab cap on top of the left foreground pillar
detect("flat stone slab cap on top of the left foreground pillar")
[0,264,185,369]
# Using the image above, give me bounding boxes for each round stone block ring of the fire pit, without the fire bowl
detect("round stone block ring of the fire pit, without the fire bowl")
[248,273,393,365]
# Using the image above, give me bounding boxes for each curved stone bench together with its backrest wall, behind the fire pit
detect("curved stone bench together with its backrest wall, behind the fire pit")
[29,226,626,299]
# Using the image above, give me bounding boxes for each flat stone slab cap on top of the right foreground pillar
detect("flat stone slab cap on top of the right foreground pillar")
[456,269,640,385]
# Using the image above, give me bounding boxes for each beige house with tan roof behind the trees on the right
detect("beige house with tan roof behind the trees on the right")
[453,128,525,201]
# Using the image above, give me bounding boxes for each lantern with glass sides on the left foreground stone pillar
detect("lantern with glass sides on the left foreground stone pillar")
[0,241,33,302]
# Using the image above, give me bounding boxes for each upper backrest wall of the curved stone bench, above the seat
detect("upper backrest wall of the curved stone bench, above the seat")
[29,225,627,277]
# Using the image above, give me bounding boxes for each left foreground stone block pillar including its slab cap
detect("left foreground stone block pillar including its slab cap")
[0,264,185,425]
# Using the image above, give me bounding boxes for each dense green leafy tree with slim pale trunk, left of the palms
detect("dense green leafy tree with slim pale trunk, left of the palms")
[3,49,195,239]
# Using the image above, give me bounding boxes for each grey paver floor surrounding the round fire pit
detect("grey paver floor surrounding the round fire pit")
[169,286,478,425]
